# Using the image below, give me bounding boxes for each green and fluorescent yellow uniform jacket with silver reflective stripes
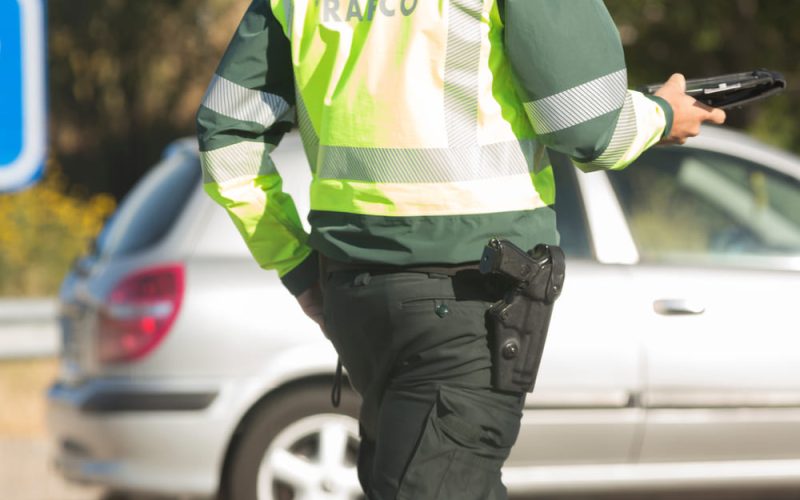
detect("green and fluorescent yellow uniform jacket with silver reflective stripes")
[197,0,671,294]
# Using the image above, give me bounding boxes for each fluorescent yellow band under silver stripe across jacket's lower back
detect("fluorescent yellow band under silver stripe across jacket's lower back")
[311,173,547,216]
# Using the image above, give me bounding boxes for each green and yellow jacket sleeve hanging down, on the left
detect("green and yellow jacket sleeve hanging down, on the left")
[197,0,317,295]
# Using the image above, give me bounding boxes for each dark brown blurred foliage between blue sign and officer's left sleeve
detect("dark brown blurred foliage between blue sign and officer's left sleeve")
[48,0,248,198]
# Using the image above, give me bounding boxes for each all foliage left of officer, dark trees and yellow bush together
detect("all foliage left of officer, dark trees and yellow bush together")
[0,0,248,296]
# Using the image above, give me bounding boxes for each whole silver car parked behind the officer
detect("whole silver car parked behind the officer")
[48,128,800,500]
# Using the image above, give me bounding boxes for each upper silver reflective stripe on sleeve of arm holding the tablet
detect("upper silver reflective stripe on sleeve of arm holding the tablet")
[525,69,628,135]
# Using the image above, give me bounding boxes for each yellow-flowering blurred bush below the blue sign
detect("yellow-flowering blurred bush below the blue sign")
[0,166,116,296]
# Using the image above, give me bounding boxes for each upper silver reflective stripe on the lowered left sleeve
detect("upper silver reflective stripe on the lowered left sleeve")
[203,75,291,128]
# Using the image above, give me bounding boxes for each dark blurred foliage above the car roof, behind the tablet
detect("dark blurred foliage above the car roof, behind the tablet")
[606,0,800,152]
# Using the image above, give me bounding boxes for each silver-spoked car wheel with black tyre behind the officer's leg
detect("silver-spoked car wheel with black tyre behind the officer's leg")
[225,385,364,500]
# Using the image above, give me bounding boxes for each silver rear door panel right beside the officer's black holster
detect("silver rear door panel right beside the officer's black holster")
[508,262,643,466]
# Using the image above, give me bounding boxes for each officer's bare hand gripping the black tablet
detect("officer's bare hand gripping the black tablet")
[655,73,725,144]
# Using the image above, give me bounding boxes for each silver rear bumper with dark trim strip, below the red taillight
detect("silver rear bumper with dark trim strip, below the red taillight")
[48,379,240,495]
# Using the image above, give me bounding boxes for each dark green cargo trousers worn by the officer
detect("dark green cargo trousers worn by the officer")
[323,271,525,500]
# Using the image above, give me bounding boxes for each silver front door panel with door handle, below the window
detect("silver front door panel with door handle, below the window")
[633,266,800,461]
